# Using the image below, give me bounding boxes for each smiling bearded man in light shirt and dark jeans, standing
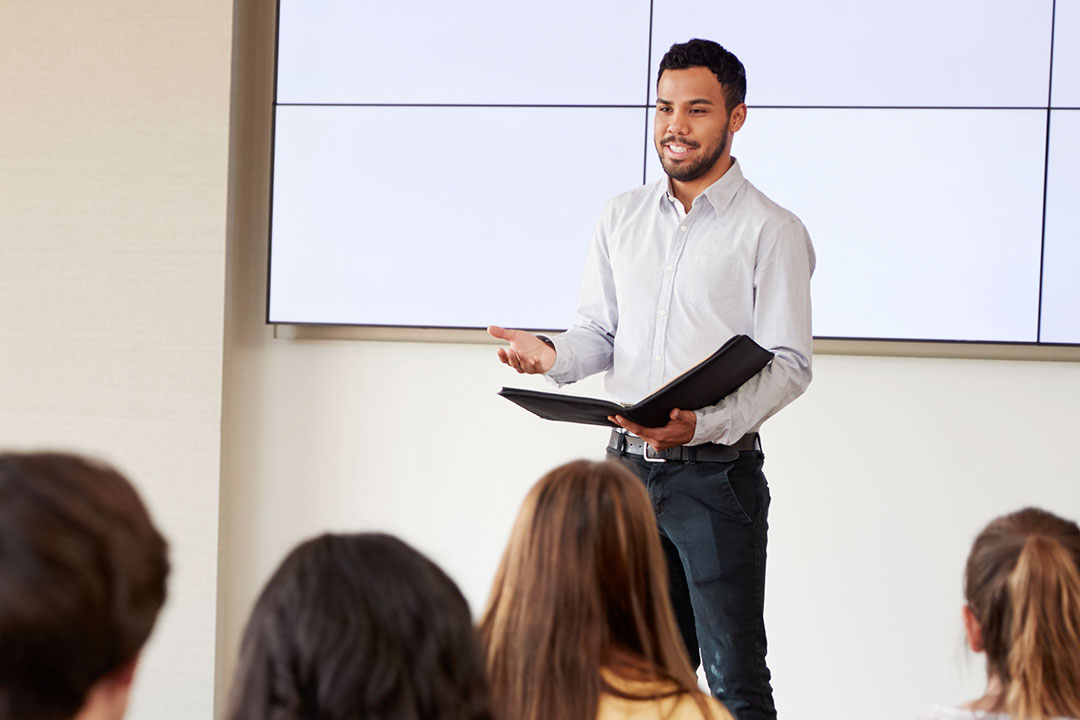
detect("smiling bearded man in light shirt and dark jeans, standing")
[488,40,814,720]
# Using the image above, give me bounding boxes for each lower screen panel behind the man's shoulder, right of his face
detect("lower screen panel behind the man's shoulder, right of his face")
[649,108,1045,342]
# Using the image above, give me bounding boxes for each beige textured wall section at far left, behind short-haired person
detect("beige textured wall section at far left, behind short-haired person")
[0,0,232,720]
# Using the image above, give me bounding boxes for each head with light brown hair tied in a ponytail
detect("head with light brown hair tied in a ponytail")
[964,507,1080,720]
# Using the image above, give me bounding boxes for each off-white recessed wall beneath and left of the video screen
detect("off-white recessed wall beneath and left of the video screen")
[220,2,1080,720]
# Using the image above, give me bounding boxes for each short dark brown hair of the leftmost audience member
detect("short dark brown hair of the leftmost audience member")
[0,453,168,720]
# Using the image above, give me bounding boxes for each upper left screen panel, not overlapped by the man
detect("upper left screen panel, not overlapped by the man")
[278,0,649,105]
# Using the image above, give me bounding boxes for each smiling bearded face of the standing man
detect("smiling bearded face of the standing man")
[653,67,731,182]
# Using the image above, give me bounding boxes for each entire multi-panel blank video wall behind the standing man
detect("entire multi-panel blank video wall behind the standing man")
[268,0,1080,344]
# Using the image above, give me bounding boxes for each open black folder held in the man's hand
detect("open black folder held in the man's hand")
[499,335,772,427]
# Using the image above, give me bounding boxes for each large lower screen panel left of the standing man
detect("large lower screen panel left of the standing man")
[270,107,645,329]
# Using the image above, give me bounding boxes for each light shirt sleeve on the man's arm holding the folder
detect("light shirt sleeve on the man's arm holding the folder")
[690,217,815,445]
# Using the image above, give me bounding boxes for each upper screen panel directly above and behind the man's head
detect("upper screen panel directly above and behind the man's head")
[650,0,1061,107]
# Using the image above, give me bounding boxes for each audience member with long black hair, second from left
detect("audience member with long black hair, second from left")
[226,533,491,720]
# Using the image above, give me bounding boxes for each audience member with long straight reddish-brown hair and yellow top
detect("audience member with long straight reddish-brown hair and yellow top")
[481,460,731,720]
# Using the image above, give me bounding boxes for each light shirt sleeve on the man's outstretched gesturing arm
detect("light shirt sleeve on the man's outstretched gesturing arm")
[545,203,619,386]
